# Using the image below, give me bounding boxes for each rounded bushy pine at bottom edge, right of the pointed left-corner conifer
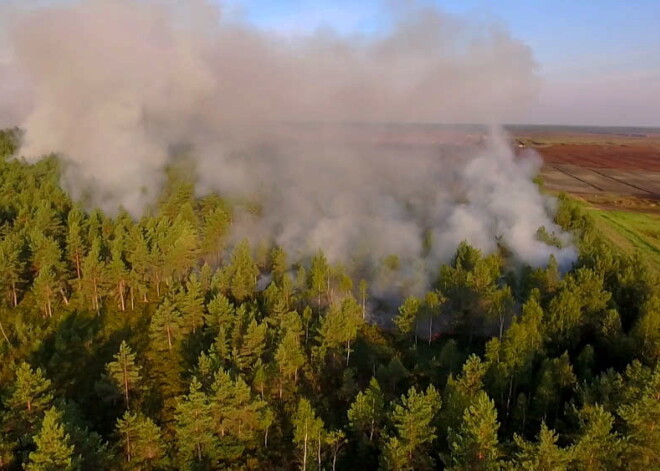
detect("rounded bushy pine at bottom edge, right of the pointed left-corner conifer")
[117,411,165,469]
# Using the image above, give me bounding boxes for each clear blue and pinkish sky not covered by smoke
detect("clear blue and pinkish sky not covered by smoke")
[224,0,660,126]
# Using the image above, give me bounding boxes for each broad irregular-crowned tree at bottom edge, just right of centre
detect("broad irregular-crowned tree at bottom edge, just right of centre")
[383,385,441,469]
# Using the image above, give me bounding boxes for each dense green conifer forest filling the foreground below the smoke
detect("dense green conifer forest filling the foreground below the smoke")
[0,126,660,471]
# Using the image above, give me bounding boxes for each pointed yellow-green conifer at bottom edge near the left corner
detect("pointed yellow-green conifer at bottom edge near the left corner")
[25,407,76,471]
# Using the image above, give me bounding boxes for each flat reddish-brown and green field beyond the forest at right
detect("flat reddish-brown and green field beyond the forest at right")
[514,128,660,270]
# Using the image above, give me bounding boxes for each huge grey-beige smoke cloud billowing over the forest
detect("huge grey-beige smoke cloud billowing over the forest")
[0,0,574,294]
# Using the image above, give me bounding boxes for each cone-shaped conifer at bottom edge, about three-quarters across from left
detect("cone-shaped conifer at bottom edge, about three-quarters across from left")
[449,391,501,470]
